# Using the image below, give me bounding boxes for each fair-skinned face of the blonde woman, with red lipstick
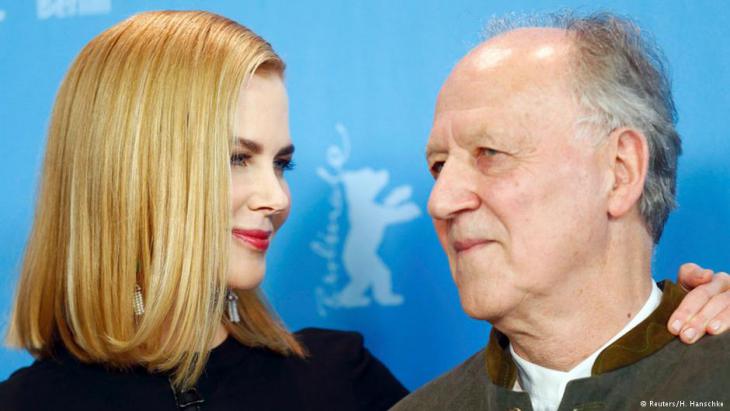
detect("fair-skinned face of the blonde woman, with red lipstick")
[228,72,294,289]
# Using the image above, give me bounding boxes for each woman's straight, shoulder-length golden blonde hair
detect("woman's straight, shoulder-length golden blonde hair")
[7,11,303,388]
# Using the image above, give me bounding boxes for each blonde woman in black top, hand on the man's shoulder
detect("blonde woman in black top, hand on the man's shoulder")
[0,8,723,410]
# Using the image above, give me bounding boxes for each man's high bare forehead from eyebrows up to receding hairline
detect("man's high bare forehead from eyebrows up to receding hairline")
[431,28,573,162]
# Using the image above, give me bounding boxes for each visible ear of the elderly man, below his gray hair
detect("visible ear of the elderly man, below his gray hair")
[608,127,649,218]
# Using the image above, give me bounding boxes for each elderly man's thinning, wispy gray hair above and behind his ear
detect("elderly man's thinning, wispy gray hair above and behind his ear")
[485,12,682,244]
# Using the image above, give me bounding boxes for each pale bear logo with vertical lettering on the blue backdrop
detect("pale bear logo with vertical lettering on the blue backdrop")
[310,124,421,315]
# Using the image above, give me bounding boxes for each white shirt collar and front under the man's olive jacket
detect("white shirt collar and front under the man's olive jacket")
[509,281,662,411]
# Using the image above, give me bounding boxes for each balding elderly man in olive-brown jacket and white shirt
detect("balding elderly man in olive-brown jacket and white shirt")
[395,15,730,410]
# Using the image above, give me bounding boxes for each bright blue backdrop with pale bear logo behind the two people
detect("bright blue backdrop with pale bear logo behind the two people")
[0,0,730,389]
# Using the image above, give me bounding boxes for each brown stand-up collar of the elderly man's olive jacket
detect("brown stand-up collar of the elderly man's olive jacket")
[485,280,686,389]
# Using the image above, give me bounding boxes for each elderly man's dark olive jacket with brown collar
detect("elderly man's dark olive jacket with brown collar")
[392,281,730,411]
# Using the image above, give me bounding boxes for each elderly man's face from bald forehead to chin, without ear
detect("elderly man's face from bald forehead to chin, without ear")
[427,29,610,322]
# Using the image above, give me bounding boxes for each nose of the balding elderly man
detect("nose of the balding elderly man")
[428,159,480,220]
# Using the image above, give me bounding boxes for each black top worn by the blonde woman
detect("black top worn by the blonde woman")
[0,328,408,411]
